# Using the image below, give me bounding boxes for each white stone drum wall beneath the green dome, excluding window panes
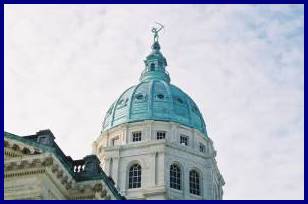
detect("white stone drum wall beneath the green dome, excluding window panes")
[93,120,224,199]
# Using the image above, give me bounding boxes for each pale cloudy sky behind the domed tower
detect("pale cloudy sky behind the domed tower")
[4,4,304,199]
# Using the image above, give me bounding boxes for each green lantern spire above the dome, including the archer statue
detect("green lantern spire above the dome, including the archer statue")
[139,23,170,83]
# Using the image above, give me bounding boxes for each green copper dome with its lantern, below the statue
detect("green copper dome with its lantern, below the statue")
[103,41,207,136]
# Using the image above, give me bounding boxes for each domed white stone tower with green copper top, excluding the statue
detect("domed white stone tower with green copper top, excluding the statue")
[93,33,224,200]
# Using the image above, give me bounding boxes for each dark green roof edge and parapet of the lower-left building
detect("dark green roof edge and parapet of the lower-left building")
[4,130,125,200]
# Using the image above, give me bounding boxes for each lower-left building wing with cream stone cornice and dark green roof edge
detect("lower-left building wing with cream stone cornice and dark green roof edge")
[4,131,124,200]
